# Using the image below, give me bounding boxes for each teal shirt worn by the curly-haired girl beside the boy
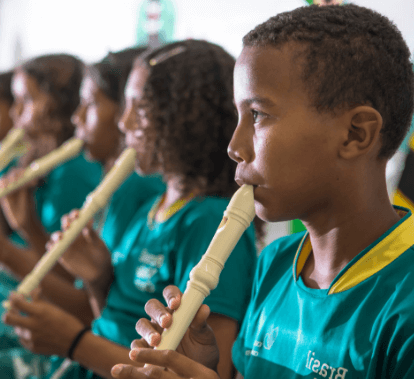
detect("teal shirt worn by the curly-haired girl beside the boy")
[92,198,256,347]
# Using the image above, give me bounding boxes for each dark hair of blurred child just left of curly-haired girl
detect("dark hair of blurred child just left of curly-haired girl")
[85,46,146,103]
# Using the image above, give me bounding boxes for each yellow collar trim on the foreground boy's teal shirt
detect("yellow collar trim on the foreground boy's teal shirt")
[293,206,414,295]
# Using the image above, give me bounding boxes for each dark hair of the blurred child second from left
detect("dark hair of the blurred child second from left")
[16,54,84,143]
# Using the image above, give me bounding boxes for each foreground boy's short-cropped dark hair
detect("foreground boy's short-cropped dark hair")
[243,4,414,159]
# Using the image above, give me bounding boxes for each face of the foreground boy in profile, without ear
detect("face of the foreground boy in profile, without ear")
[228,44,345,221]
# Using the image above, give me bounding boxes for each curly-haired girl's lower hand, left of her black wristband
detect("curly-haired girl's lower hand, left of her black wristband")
[3,290,84,357]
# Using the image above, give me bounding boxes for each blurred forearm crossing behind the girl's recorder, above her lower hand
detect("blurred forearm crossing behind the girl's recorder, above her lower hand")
[3,244,93,324]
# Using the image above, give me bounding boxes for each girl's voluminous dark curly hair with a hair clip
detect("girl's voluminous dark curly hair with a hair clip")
[135,40,263,240]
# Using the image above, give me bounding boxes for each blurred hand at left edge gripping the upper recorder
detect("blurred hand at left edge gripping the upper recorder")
[0,168,41,233]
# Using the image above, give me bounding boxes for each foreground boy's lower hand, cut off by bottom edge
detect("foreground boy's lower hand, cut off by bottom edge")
[111,348,220,379]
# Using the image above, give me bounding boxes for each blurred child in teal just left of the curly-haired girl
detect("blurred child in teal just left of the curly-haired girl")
[0,48,164,378]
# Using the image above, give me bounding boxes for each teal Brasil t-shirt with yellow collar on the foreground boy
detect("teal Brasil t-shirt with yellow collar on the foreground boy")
[233,207,414,379]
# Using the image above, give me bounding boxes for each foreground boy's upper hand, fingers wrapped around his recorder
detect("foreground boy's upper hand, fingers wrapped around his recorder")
[131,286,219,370]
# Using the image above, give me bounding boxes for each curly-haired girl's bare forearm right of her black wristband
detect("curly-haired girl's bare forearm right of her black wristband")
[73,332,142,379]
